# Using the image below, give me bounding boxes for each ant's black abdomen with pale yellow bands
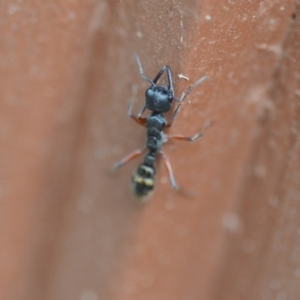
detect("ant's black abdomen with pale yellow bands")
[131,164,155,202]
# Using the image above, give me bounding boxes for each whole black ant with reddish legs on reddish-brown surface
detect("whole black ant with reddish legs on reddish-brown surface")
[113,54,209,202]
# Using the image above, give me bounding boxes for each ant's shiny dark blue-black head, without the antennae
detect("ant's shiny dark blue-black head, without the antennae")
[145,85,174,113]
